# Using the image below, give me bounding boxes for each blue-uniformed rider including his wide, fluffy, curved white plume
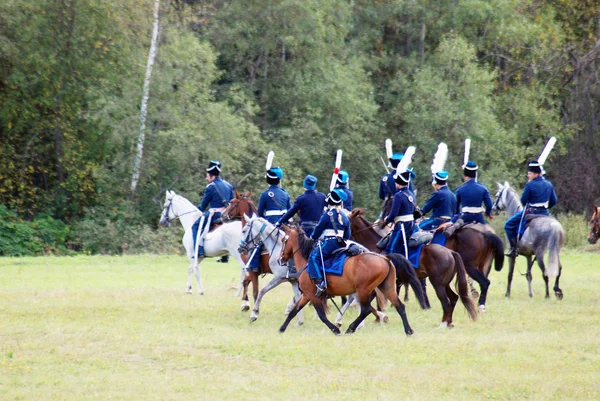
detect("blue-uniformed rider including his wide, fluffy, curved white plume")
[419,142,456,230]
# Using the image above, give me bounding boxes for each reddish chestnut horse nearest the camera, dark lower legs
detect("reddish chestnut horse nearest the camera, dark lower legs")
[279,228,413,335]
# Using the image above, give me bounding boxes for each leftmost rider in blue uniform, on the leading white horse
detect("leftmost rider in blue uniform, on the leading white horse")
[192,160,235,258]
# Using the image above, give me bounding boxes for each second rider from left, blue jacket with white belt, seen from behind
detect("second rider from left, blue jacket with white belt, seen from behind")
[248,167,291,271]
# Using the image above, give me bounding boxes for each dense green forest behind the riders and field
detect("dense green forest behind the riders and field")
[0,0,600,255]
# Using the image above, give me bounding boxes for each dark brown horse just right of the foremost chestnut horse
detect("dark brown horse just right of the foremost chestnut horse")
[348,209,477,327]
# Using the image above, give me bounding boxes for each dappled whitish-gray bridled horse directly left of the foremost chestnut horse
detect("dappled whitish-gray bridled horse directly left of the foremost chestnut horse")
[240,215,304,325]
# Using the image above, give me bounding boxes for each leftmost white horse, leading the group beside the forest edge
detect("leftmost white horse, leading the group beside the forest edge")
[159,191,245,296]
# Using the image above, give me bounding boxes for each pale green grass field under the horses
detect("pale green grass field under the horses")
[0,251,600,400]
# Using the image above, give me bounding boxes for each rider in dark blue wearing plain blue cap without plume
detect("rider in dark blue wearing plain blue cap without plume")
[277,174,326,236]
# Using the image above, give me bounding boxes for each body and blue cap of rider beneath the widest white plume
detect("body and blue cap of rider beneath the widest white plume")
[419,171,456,230]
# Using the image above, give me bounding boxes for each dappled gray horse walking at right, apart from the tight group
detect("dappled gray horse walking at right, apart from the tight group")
[494,182,565,299]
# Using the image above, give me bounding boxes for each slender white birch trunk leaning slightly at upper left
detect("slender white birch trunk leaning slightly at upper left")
[131,0,160,198]
